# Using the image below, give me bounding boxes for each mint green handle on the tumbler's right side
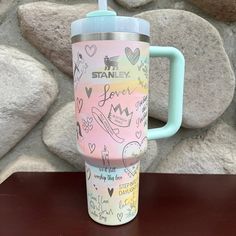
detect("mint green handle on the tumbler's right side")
[148,46,185,140]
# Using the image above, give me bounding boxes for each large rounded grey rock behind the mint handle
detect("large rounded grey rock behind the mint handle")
[136,10,235,128]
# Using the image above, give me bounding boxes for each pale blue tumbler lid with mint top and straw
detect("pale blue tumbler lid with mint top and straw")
[71,0,150,37]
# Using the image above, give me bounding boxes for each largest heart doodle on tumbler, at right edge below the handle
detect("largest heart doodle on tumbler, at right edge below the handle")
[122,137,147,176]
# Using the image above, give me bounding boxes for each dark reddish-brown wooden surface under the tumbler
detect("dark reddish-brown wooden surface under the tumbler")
[0,173,236,236]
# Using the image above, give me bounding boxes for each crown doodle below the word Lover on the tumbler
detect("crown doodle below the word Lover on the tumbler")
[108,104,133,127]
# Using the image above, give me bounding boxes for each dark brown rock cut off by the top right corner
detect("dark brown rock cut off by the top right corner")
[188,0,236,21]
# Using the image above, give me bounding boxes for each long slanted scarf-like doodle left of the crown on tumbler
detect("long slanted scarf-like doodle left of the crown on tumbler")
[91,107,124,143]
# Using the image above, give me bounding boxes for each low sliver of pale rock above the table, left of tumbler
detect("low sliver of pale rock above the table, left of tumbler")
[0,155,71,183]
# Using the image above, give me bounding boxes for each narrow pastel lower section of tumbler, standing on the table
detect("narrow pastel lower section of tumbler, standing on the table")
[85,162,140,225]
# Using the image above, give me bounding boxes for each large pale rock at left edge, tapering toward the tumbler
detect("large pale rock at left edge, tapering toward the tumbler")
[0,46,58,157]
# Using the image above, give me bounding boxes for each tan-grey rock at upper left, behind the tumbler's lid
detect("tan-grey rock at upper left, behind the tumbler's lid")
[18,2,97,76]
